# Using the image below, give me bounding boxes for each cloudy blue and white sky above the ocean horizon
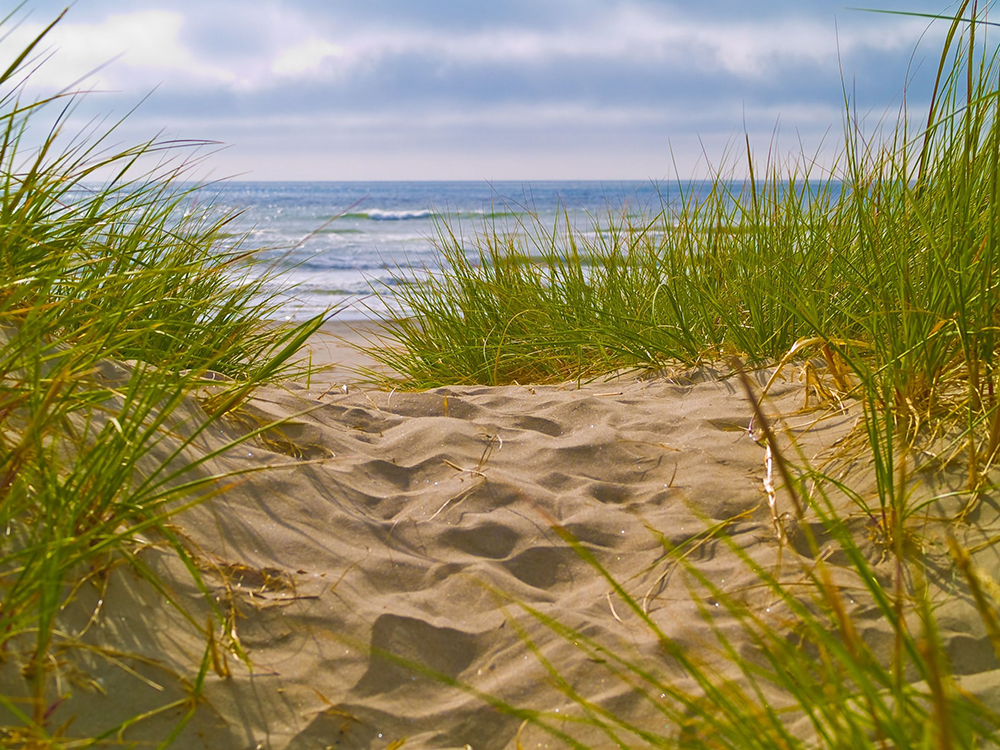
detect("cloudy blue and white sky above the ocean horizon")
[0,0,968,181]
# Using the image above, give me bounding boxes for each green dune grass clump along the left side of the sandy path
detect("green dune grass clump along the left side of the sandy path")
[0,10,320,748]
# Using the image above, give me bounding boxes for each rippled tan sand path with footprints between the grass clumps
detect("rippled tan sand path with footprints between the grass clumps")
[0,326,1000,750]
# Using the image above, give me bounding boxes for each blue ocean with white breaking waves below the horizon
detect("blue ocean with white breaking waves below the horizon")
[196,181,696,320]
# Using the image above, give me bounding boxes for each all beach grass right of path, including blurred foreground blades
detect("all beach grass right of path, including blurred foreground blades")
[360,0,1000,748]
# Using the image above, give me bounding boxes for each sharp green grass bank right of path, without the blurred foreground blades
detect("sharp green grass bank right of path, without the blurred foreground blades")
[373,3,1000,465]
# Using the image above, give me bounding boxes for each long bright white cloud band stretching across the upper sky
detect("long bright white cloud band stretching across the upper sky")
[5,2,926,93]
